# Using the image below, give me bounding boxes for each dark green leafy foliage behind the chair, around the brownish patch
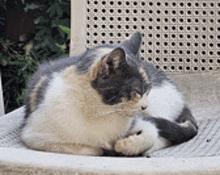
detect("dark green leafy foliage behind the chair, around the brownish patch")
[0,0,70,112]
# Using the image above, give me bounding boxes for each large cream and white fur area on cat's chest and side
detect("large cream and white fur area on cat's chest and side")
[22,67,137,155]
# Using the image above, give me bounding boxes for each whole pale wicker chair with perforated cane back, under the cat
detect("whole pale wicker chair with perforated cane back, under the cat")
[0,0,220,175]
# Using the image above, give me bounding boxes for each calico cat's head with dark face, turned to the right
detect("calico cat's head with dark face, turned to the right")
[89,32,150,116]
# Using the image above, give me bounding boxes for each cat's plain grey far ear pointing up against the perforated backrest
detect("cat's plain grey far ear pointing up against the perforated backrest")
[122,32,142,55]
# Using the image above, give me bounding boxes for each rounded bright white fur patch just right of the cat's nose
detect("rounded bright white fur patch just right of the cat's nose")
[146,81,184,121]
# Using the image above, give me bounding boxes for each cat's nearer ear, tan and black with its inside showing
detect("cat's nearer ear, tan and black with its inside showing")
[91,47,127,80]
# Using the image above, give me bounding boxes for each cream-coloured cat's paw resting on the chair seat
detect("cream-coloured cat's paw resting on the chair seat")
[114,134,153,156]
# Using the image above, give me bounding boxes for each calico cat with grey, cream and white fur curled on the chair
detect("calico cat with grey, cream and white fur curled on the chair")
[21,32,198,156]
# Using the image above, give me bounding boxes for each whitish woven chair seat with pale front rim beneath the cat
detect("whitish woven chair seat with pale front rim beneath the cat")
[0,107,220,174]
